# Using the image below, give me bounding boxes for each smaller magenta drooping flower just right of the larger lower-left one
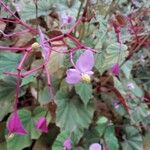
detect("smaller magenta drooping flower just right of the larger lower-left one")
[36,117,48,133]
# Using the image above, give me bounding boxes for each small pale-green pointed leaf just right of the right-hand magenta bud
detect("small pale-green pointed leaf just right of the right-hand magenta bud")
[121,60,133,79]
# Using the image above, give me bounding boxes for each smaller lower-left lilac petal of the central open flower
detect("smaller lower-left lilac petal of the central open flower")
[66,69,81,84]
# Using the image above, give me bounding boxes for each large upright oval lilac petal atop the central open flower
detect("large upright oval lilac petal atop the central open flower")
[76,50,94,73]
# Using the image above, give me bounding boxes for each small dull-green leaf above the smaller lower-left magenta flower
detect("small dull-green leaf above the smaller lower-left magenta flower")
[39,86,51,105]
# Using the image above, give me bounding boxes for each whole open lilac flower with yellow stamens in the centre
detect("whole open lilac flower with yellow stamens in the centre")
[66,50,94,84]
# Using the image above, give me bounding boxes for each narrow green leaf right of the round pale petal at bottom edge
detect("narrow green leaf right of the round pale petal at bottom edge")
[104,127,119,150]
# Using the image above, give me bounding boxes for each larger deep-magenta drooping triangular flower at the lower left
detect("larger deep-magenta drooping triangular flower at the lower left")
[7,111,27,135]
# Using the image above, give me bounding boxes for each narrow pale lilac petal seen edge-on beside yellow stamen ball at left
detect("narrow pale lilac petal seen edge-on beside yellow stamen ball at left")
[38,28,50,60]
